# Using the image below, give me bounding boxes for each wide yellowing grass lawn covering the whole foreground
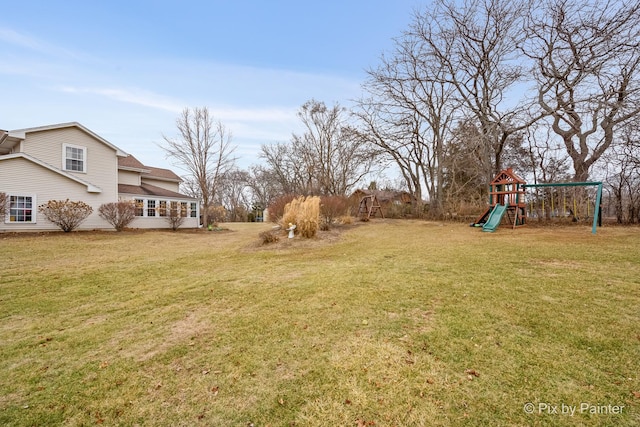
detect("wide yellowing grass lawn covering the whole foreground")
[0,220,640,427]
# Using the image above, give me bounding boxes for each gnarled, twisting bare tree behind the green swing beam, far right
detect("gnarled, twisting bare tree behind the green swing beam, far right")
[522,0,640,182]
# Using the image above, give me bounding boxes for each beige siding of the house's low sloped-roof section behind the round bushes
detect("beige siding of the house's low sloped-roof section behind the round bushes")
[0,158,117,231]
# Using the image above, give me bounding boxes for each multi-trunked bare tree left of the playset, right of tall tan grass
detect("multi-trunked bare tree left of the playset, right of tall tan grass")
[356,28,457,214]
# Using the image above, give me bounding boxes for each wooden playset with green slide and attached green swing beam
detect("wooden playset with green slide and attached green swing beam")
[471,168,602,234]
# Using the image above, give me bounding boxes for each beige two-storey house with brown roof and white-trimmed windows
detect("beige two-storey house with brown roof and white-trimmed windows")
[0,122,200,231]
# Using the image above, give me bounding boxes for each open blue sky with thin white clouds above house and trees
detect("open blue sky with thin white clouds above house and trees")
[0,0,425,172]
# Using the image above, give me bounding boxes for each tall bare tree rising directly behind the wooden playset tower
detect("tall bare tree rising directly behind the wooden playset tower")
[405,0,536,182]
